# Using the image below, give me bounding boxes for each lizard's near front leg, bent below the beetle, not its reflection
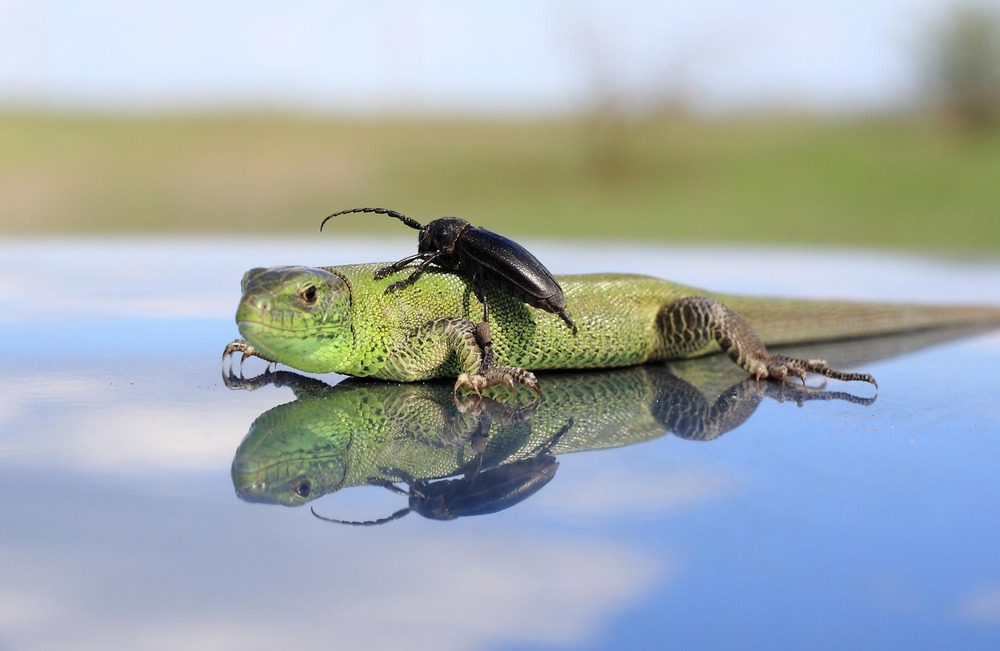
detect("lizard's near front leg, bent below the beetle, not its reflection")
[386,317,538,394]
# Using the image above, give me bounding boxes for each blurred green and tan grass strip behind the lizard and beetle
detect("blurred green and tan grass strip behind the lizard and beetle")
[0,113,1000,252]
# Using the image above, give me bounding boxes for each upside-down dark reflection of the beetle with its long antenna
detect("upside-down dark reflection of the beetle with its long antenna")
[312,454,559,526]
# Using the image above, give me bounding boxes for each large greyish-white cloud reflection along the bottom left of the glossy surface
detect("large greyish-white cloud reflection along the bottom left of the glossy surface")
[0,524,671,651]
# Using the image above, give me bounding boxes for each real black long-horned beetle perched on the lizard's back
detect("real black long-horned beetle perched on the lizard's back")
[319,208,577,339]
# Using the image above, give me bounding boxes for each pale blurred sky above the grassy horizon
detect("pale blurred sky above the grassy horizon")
[0,0,1000,114]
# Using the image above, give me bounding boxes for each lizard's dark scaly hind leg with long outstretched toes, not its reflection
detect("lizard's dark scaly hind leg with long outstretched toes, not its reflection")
[658,297,878,387]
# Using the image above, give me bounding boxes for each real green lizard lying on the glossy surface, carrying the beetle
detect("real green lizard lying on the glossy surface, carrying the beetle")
[225,263,1000,391]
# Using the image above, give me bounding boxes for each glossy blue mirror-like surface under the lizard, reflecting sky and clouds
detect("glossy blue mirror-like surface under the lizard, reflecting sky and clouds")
[0,237,1000,649]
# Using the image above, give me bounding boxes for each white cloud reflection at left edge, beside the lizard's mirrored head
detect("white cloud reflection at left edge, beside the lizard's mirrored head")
[0,372,266,474]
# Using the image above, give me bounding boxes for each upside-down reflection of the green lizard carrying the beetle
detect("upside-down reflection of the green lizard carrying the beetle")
[227,366,874,510]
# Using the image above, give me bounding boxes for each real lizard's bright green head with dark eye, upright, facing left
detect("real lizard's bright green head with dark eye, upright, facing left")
[236,267,353,373]
